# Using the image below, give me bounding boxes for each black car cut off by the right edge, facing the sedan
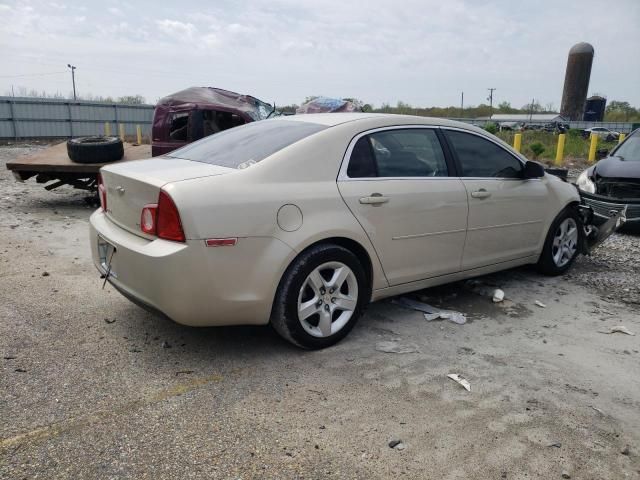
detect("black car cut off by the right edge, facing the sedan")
[576,129,640,226]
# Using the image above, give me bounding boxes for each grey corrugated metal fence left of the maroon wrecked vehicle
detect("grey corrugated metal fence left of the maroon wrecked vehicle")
[0,97,154,140]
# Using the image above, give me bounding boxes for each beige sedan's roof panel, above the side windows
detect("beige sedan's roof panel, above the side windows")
[276,112,478,127]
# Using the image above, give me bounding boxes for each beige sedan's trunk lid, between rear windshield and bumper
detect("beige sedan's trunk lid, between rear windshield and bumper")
[100,157,233,239]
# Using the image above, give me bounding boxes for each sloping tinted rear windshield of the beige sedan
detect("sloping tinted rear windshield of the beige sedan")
[167,119,327,169]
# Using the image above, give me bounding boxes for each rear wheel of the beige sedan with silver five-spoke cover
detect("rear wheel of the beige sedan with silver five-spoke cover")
[271,244,370,349]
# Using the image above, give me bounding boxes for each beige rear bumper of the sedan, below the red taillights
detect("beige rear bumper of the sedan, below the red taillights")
[90,211,294,326]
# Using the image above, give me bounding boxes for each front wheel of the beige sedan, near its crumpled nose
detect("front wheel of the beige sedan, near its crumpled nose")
[537,207,584,275]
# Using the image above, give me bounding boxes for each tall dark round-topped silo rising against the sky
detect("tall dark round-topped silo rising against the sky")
[560,42,594,120]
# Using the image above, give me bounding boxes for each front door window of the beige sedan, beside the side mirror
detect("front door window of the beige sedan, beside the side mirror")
[445,130,523,178]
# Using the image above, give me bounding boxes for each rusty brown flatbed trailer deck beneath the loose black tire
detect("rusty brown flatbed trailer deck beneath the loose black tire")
[7,142,151,191]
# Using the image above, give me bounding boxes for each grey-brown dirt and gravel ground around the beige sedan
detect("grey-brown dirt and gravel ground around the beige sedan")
[0,146,640,479]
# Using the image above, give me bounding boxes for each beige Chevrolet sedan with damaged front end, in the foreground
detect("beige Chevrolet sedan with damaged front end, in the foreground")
[90,113,604,348]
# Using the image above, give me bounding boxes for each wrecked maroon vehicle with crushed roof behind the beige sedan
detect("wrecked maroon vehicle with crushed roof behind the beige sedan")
[151,87,277,157]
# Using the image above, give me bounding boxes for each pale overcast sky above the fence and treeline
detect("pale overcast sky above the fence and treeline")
[0,0,640,108]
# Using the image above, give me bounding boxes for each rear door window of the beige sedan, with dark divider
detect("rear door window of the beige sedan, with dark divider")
[347,128,449,178]
